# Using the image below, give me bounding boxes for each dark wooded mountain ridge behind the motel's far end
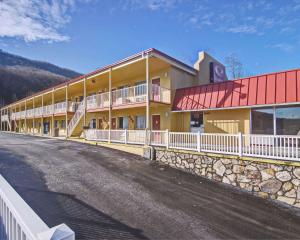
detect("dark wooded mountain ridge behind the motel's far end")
[0,49,82,106]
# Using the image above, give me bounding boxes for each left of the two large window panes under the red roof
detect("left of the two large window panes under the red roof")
[251,108,274,135]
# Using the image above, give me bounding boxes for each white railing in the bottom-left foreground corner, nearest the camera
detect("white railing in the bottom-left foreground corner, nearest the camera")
[0,175,75,240]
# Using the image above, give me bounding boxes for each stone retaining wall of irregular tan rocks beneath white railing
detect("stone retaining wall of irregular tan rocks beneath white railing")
[155,149,300,208]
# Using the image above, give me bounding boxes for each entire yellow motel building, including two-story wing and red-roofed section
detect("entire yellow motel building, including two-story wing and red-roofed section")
[1,49,300,141]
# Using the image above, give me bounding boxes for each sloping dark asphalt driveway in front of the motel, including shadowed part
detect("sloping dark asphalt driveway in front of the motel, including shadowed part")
[0,133,300,239]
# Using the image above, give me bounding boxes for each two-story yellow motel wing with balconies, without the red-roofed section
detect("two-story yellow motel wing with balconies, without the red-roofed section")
[1,49,222,136]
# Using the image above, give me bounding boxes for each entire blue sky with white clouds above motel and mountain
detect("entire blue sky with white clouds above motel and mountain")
[0,0,300,75]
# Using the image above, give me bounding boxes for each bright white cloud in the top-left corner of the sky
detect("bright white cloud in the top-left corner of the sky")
[0,0,89,42]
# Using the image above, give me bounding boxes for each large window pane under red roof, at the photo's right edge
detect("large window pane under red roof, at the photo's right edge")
[275,107,300,135]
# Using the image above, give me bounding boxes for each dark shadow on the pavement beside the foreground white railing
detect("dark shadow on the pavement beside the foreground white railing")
[0,147,148,240]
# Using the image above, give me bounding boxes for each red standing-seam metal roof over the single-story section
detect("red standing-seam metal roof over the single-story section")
[172,69,300,111]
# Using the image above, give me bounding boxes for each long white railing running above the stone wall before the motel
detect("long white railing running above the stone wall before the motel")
[85,129,300,161]
